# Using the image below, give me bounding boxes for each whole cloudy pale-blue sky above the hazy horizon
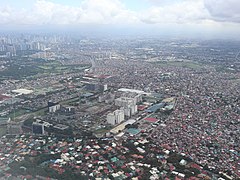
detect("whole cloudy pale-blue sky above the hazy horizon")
[0,0,240,37]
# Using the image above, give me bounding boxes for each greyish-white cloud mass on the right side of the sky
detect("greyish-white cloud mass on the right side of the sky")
[142,0,240,23]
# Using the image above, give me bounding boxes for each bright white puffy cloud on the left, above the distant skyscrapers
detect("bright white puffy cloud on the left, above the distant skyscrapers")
[0,0,138,25]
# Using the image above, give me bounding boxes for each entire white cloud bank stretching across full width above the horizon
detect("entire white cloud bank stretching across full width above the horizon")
[0,0,240,25]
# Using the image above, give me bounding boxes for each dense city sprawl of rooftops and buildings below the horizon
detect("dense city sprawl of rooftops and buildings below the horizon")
[0,34,240,180]
